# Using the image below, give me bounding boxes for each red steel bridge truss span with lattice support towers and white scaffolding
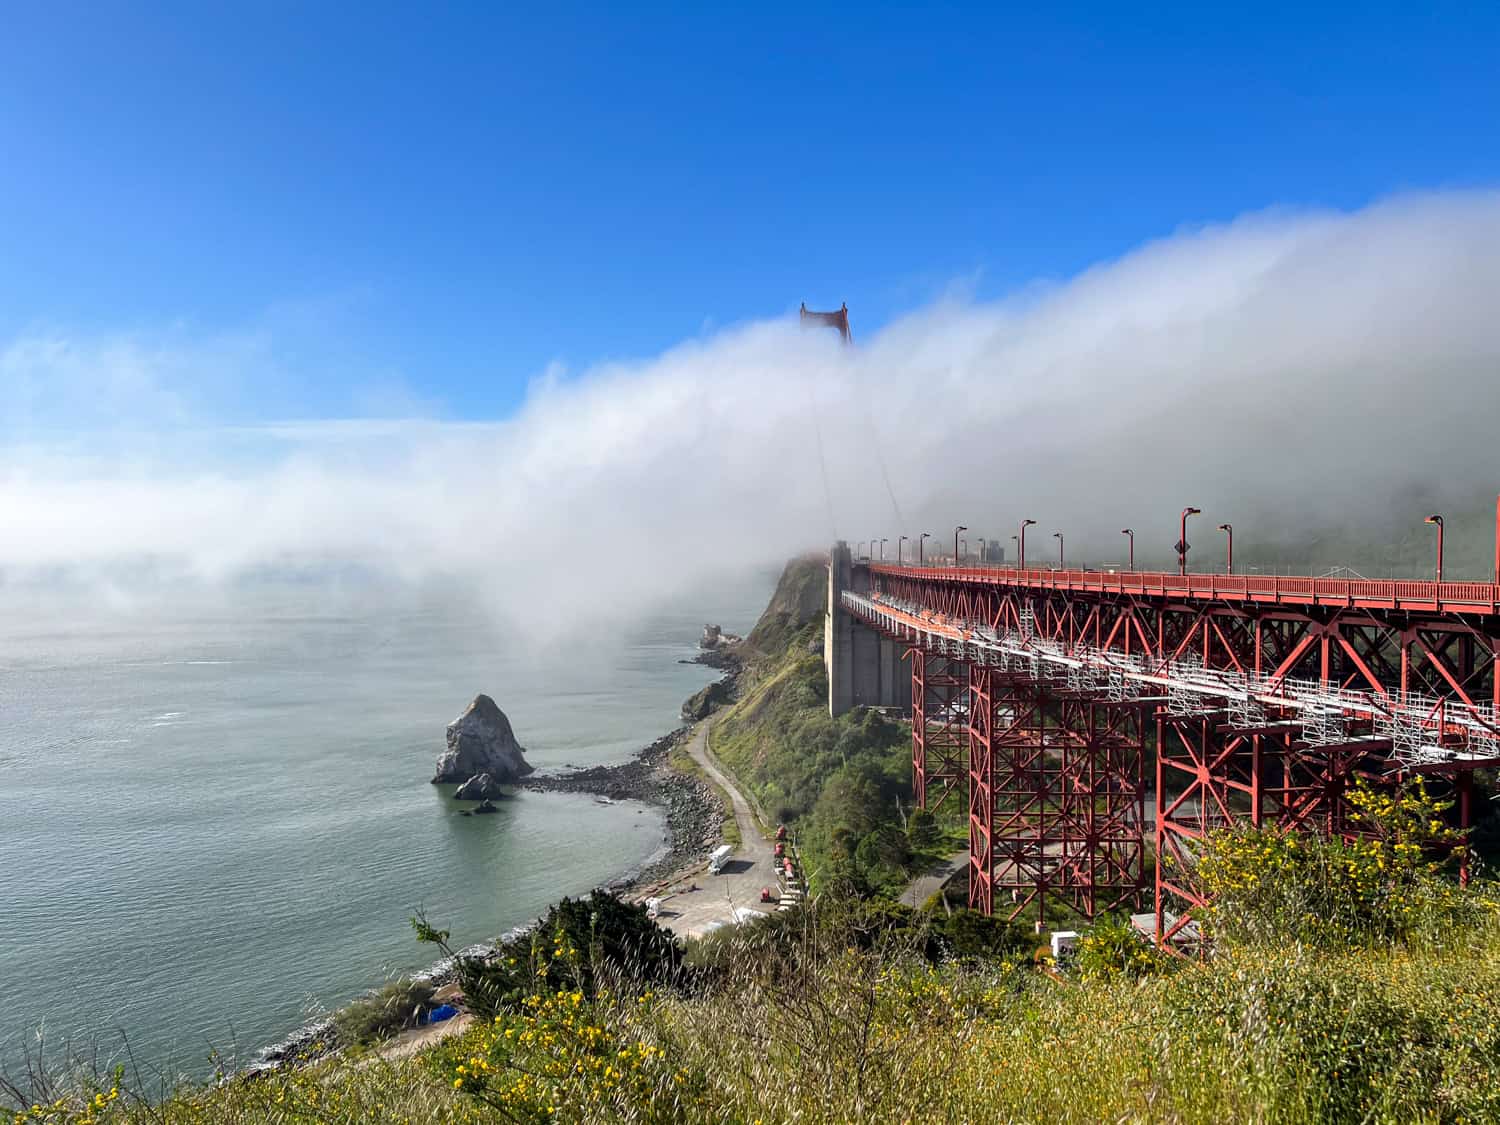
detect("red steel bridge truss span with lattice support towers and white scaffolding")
[845,564,1500,941]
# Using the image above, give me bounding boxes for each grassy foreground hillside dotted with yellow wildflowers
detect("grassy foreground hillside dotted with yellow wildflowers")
[17,911,1500,1125]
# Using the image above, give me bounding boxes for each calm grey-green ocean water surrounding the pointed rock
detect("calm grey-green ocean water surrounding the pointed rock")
[0,584,770,1074]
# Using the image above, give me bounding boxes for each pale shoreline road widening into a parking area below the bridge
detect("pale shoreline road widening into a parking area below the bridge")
[656,720,776,938]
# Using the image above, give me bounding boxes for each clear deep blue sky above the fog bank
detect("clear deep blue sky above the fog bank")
[0,3,1500,419]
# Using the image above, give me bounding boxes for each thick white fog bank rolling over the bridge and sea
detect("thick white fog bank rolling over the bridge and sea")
[0,192,1500,629]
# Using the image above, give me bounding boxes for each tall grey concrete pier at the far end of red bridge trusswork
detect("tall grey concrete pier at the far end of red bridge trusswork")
[824,540,912,716]
